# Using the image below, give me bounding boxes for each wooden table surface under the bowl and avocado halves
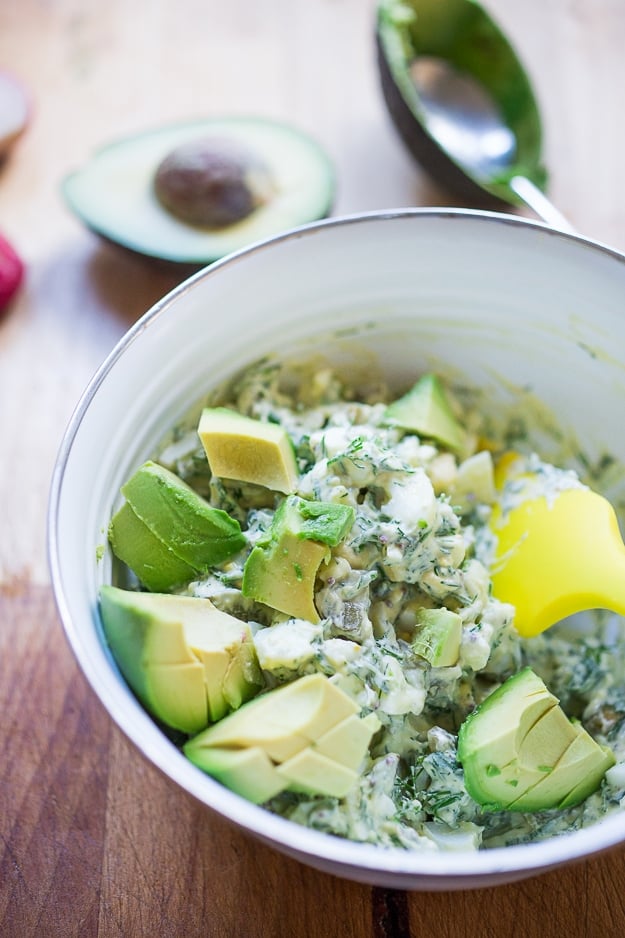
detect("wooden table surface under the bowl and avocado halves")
[0,0,625,938]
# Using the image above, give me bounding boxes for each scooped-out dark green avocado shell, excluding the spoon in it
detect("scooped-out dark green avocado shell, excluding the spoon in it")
[376,0,547,208]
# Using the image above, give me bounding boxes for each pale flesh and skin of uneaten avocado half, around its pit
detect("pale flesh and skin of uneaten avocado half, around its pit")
[62,117,335,268]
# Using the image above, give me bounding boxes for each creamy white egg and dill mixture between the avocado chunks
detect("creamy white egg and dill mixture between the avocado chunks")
[159,367,625,850]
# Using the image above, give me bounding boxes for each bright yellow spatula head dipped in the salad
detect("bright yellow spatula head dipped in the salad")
[491,456,625,637]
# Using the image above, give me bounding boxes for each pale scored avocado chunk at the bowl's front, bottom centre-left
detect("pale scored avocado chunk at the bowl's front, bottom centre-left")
[184,674,380,804]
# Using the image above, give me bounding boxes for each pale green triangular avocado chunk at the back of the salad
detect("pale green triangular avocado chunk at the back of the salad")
[384,374,466,452]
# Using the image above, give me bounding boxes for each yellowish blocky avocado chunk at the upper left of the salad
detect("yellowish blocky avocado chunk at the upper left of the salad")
[198,407,299,494]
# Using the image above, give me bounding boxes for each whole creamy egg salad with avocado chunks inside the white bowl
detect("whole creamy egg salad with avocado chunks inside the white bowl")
[101,361,625,851]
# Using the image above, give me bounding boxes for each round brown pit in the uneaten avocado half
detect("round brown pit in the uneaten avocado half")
[154,137,275,228]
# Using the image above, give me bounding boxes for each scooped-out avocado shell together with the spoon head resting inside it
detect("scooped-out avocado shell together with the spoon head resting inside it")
[376,0,547,208]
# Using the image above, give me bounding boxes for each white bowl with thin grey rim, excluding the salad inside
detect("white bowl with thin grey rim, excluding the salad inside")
[48,209,625,890]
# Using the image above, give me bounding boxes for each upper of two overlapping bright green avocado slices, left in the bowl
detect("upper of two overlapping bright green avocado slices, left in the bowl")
[121,461,245,572]
